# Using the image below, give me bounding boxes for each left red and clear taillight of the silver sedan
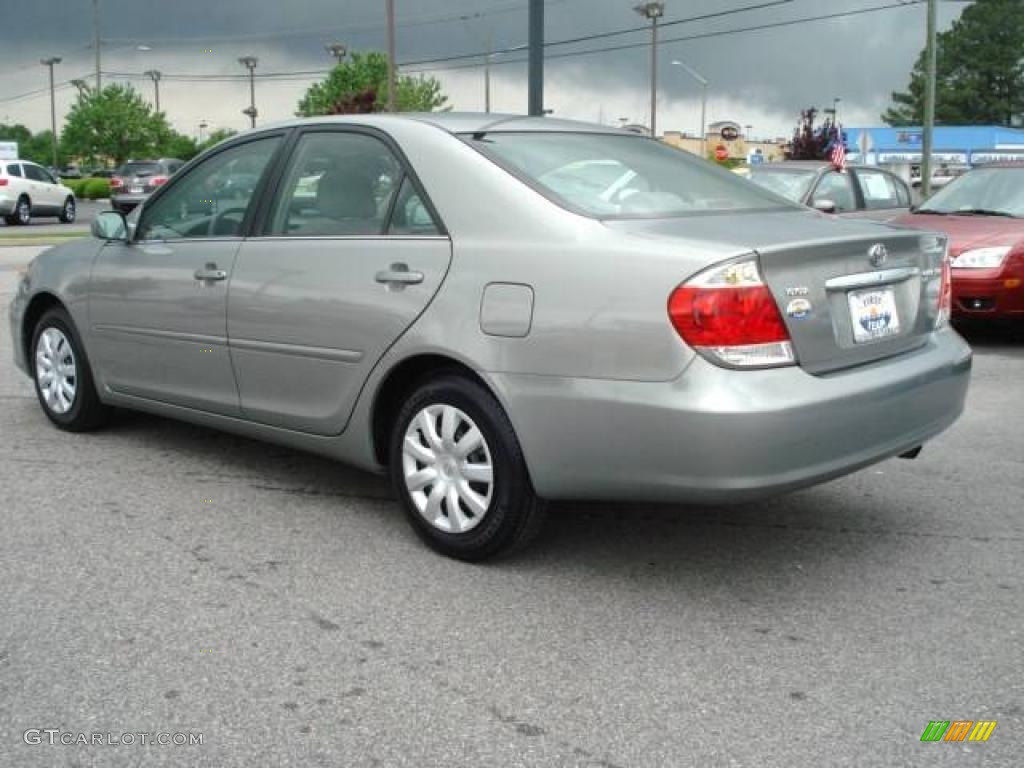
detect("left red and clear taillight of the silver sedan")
[669,260,795,367]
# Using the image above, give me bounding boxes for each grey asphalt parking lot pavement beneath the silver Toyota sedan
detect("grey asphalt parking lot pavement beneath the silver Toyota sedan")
[0,248,1024,768]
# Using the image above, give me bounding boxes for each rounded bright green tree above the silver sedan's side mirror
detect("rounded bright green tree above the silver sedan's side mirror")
[63,85,172,165]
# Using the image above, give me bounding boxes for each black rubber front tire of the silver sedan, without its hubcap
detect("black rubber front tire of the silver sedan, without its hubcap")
[29,307,110,432]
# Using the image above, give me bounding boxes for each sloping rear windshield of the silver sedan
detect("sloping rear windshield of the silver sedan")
[464,132,792,218]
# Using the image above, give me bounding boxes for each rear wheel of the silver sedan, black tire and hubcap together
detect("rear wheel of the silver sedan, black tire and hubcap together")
[389,375,545,561]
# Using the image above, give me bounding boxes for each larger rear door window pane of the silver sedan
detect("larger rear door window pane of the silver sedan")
[270,131,402,237]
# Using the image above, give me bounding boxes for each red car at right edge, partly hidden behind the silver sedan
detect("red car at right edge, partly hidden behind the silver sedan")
[891,165,1024,317]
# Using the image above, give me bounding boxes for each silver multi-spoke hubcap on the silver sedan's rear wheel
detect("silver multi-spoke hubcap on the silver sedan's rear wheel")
[401,404,495,534]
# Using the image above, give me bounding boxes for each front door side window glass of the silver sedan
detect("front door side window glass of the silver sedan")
[138,136,281,240]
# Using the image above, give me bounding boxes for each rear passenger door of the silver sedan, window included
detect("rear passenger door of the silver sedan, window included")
[227,127,452,435]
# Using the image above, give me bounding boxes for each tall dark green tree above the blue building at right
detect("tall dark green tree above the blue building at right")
[882,0,1024,126]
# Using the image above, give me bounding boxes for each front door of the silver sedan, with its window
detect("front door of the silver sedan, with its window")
[89,133,283,415]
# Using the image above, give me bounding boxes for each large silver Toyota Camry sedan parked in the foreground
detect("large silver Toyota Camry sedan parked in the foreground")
[10,113,971,560]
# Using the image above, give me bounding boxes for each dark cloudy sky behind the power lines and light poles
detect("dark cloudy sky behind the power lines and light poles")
[0,0,967,141]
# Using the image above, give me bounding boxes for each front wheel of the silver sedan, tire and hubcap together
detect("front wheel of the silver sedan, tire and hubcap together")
[31,308,109,432]
